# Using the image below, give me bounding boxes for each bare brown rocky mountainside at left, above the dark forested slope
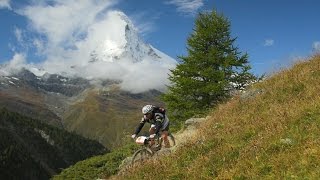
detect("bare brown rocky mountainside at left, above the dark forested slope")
[0,69,90,127]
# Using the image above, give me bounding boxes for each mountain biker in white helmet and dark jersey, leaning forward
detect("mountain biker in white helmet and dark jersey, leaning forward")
[131,105,170,148]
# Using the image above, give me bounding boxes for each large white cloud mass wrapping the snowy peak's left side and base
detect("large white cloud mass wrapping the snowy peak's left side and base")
[10,0,174,93]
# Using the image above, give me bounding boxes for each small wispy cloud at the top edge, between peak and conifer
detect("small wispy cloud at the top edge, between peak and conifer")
[165,0,203,14]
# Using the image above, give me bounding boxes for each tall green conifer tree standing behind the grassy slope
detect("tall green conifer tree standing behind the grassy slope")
[163,10,256,121]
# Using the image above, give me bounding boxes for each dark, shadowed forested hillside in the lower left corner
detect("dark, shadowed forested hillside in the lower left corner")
[0,108,109,179]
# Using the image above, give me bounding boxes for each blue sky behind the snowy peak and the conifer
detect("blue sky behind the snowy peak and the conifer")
[0,0,320,74]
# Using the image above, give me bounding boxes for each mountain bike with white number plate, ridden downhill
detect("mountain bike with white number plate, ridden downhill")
[131,133,176,165]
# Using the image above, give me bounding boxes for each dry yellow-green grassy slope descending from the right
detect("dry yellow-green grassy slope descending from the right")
[115,56,320,179]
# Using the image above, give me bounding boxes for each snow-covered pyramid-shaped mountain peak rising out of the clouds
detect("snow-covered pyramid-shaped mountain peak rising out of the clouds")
[90,11,175,64]
